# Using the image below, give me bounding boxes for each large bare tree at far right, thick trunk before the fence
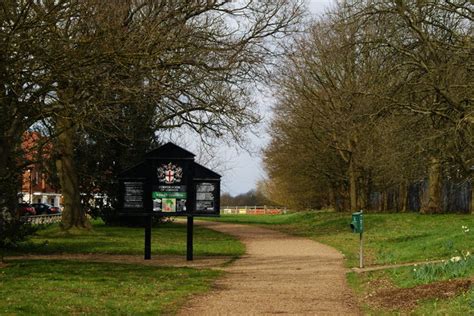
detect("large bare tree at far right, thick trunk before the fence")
[353,0,474,212]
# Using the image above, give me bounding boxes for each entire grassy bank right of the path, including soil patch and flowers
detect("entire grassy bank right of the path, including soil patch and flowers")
[215,212,474,315]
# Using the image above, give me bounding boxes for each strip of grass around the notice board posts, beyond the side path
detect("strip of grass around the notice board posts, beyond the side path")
[15,221,245,257]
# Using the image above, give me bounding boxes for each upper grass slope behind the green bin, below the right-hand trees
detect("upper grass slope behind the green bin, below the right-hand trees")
[219,212,474,267]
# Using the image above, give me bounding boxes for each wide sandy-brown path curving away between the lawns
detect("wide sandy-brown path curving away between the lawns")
[179,221,360,315]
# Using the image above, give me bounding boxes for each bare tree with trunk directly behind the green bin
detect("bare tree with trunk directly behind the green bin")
[264,2,390,210]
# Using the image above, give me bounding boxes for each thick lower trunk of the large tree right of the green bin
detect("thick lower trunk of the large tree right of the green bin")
[421,157,442,214]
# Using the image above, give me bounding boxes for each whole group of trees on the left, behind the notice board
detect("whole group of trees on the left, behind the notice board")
[0,0,302,229]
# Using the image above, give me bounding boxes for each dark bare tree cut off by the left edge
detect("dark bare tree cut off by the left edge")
[0,0,73,226]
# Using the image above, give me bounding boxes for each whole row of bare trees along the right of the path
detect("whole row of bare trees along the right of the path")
[264,0,474,213]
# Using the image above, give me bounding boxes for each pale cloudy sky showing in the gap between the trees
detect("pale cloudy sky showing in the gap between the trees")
[211,0,335,195]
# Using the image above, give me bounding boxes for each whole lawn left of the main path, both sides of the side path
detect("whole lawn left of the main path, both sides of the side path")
[0,221,245,315]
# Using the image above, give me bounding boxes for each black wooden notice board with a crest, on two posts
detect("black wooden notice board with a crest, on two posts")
[119,143,221,260]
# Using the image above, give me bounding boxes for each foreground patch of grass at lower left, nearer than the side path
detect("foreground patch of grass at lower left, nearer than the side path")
[0,260,221,315]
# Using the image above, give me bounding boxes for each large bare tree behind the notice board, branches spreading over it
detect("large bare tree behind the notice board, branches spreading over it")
[3,0,301,229]
